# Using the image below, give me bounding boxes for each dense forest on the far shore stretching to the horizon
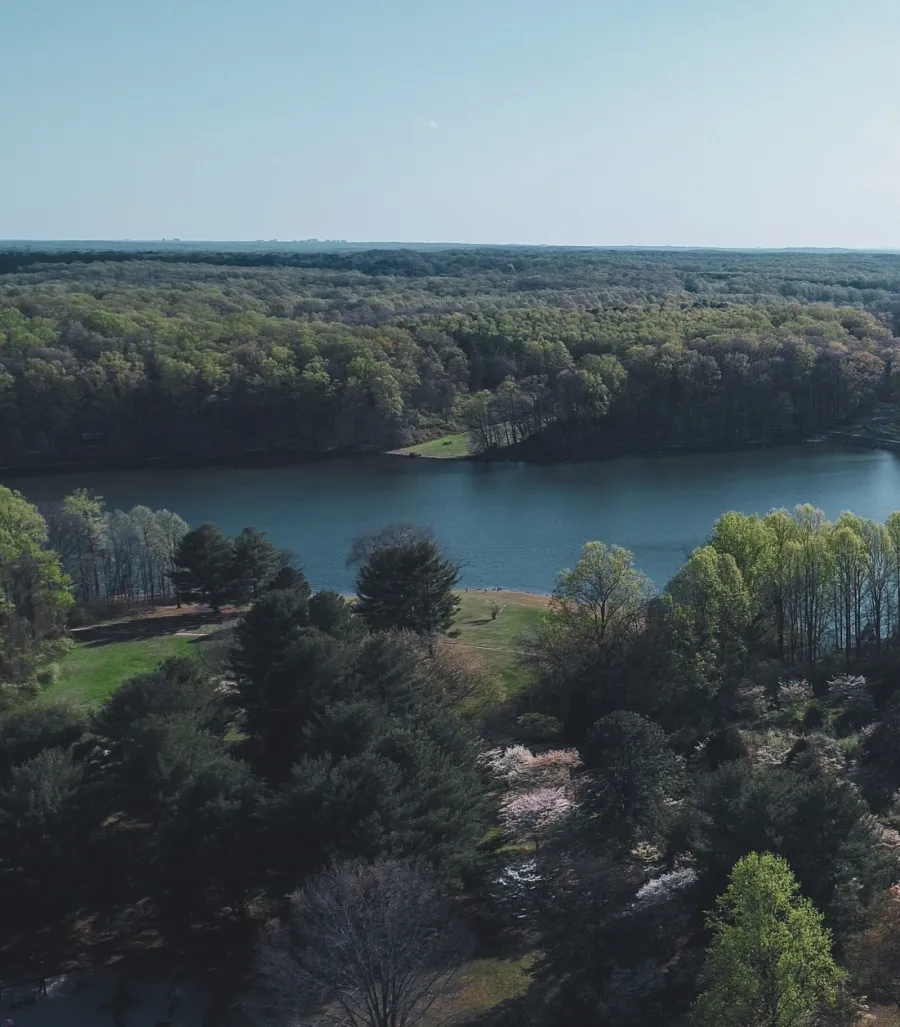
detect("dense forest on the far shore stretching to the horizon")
[0,246,900,468]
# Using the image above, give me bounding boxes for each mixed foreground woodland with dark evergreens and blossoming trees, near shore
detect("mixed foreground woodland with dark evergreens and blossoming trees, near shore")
[7,489,900,1027]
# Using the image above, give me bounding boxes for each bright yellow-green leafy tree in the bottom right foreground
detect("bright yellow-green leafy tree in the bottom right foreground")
[693,852,846,1027]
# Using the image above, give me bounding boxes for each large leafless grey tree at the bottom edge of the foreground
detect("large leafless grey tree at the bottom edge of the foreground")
[248,860,466,1027]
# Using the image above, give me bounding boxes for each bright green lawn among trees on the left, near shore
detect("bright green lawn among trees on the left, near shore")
[42,635,196,709]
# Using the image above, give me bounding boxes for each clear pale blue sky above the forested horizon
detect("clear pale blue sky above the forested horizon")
[0,0,900,249]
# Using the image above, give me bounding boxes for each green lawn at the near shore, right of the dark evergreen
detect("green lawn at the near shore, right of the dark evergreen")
[454,592,547,695]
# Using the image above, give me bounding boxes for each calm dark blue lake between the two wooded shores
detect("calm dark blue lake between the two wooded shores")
[3,444,900,592]
